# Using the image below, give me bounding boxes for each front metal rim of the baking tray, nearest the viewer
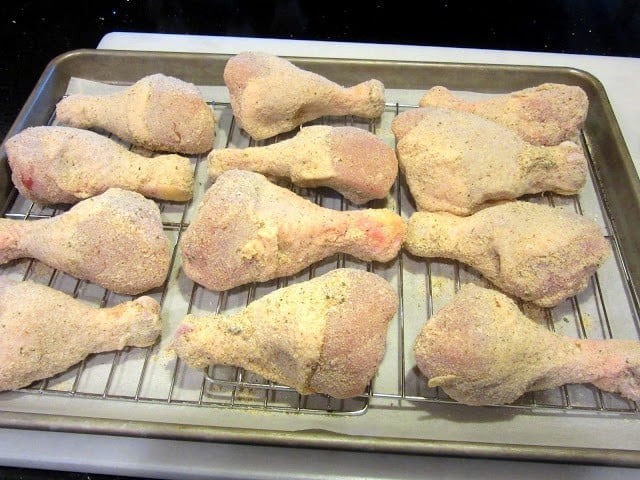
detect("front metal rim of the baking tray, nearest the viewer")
[5,413,640,467]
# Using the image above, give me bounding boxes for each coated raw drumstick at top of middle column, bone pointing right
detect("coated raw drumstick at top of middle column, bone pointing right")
[224,52,385,140]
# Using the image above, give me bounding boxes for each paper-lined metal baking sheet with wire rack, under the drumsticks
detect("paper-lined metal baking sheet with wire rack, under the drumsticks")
[0,50,640,465]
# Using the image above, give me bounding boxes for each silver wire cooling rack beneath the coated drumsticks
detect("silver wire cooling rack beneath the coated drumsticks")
[0,95,640,417]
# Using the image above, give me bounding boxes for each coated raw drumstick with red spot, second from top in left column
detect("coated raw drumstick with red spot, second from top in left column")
[5,127,193,205]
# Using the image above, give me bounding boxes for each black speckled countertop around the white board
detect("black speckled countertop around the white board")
[0,0,640,479]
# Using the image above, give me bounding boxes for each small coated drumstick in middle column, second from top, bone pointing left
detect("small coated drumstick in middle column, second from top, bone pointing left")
[208,125,398,205]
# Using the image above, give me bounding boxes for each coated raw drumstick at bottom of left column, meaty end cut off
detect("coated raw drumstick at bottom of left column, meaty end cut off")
[0,277,162,391]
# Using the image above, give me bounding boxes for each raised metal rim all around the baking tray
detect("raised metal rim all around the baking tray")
[0,49,640,466]
